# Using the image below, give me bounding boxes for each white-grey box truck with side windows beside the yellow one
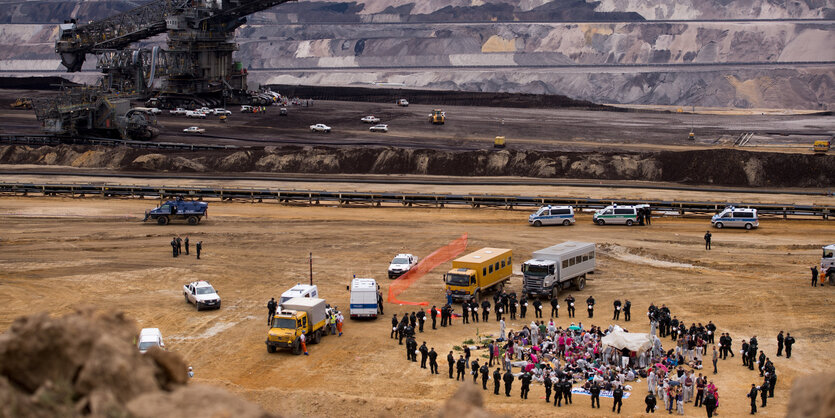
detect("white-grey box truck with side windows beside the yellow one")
[522,241,595,298]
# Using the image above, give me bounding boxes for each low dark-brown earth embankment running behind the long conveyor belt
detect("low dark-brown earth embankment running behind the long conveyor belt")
[0,145,835,187]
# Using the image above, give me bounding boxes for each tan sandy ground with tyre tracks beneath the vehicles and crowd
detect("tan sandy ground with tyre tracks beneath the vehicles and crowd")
[0,197,835,416]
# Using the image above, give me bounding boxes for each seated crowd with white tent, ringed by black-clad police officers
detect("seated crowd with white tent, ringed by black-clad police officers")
[390,292,794,417]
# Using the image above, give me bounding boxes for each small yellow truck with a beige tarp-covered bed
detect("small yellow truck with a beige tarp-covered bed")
[266,297,328,355]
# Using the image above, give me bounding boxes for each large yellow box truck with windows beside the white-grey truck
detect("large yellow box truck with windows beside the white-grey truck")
[444,247,513,302]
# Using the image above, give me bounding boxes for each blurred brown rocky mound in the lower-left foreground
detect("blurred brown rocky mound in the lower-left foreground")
[0,309,278,418]
